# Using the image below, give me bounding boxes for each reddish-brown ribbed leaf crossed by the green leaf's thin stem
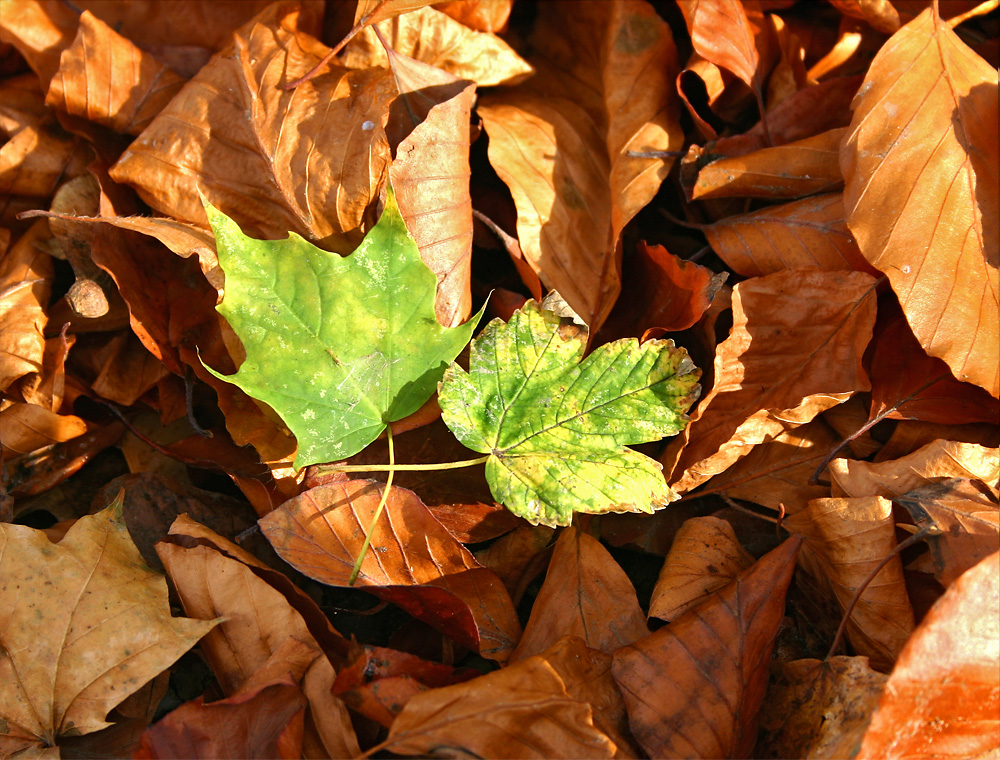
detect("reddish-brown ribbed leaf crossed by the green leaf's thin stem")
[260,480,521,662]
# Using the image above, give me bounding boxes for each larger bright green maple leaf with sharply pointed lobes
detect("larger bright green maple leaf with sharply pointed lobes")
[205,188,478,467]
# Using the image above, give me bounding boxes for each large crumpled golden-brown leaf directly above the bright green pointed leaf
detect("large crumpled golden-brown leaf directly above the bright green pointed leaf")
[111,3,396,252]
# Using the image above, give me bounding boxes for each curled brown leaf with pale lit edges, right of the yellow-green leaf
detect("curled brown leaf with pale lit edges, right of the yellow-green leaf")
[660,270,875,492]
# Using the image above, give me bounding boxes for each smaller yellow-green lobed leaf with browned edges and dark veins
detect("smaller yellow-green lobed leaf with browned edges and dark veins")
[438,301,701,525]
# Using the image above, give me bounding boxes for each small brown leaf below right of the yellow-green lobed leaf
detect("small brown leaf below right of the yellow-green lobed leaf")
[649,517,754,620]
